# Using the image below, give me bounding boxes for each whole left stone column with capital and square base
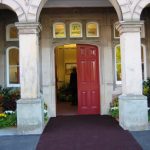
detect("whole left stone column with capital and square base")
[16,23,44,134]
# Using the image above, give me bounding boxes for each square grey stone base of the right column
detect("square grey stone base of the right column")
[119,95,148,131]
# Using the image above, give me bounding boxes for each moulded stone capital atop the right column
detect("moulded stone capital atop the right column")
[115,21,144,34]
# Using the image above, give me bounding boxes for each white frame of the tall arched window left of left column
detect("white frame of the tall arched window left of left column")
[6,46,20,87]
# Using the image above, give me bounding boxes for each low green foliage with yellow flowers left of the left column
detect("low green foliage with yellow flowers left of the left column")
[0,113,17,128]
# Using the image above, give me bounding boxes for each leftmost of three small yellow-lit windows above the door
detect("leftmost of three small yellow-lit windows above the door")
[53,22,66,38]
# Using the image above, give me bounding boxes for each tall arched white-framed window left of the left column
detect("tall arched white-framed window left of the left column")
[6,47,20,87]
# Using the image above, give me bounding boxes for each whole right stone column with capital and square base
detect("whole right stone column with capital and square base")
[116,21,148,131]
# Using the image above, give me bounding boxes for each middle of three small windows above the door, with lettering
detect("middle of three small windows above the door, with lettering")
[70,22,82,38]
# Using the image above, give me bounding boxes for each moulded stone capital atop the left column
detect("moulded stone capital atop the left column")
[15,22,42,34]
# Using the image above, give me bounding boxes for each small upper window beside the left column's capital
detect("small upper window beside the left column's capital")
[6,24,19,41]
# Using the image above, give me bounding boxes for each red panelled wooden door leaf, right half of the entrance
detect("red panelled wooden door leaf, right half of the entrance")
[77,45,100,114]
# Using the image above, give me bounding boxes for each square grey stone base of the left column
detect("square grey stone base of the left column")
[17,99,44,135]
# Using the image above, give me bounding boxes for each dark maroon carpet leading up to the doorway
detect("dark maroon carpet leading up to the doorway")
[37,115,142,150]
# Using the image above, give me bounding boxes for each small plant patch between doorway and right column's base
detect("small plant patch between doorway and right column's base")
[109,98,119,119]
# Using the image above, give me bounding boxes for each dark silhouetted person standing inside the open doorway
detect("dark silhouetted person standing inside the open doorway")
[70,67,78,105]
